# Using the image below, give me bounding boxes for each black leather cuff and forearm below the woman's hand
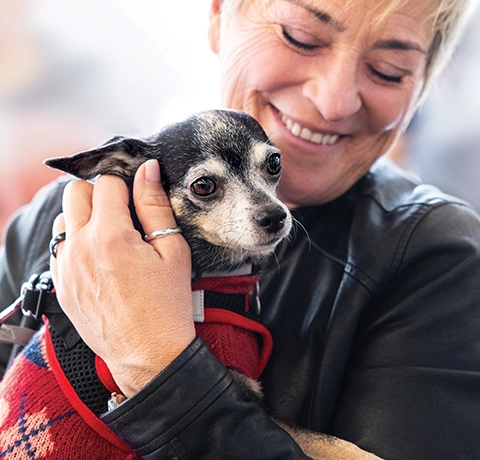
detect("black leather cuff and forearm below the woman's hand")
[102,338,309,460]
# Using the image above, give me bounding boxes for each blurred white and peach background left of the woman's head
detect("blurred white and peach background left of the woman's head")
[0,0,219,237]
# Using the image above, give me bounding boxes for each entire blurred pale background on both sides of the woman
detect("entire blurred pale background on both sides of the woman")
[0,0,480,237]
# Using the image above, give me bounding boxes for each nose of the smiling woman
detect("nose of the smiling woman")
[303,52,362,122]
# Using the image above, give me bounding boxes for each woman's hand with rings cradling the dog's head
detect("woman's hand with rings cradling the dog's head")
[50,160,195,396]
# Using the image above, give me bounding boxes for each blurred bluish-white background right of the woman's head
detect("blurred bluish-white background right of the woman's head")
[392,4,480,212]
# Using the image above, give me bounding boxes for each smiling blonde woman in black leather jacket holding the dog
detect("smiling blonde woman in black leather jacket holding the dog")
[2,0,480,459]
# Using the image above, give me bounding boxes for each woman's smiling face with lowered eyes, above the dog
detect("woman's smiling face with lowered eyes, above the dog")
[210,0,434,207]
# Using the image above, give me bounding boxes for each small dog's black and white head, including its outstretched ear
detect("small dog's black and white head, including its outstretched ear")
[45,110,291,272]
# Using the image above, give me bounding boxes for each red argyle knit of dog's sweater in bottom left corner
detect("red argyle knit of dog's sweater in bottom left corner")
[0,328,139,460]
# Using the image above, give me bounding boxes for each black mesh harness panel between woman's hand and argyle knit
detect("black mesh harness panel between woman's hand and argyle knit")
[50,326,110,415]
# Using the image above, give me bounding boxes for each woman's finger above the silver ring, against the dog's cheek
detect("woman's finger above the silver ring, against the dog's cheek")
[133,160,177,234]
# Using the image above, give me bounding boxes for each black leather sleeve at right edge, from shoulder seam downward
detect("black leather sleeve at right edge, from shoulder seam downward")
[333,203,480,460]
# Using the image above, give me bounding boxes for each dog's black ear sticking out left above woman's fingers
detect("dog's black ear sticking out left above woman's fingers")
[44,137,152,180]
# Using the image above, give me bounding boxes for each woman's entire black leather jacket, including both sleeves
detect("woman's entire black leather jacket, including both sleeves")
[0,160,480,460]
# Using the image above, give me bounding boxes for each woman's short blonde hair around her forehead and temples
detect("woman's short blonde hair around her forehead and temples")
[223,0,478,93]
